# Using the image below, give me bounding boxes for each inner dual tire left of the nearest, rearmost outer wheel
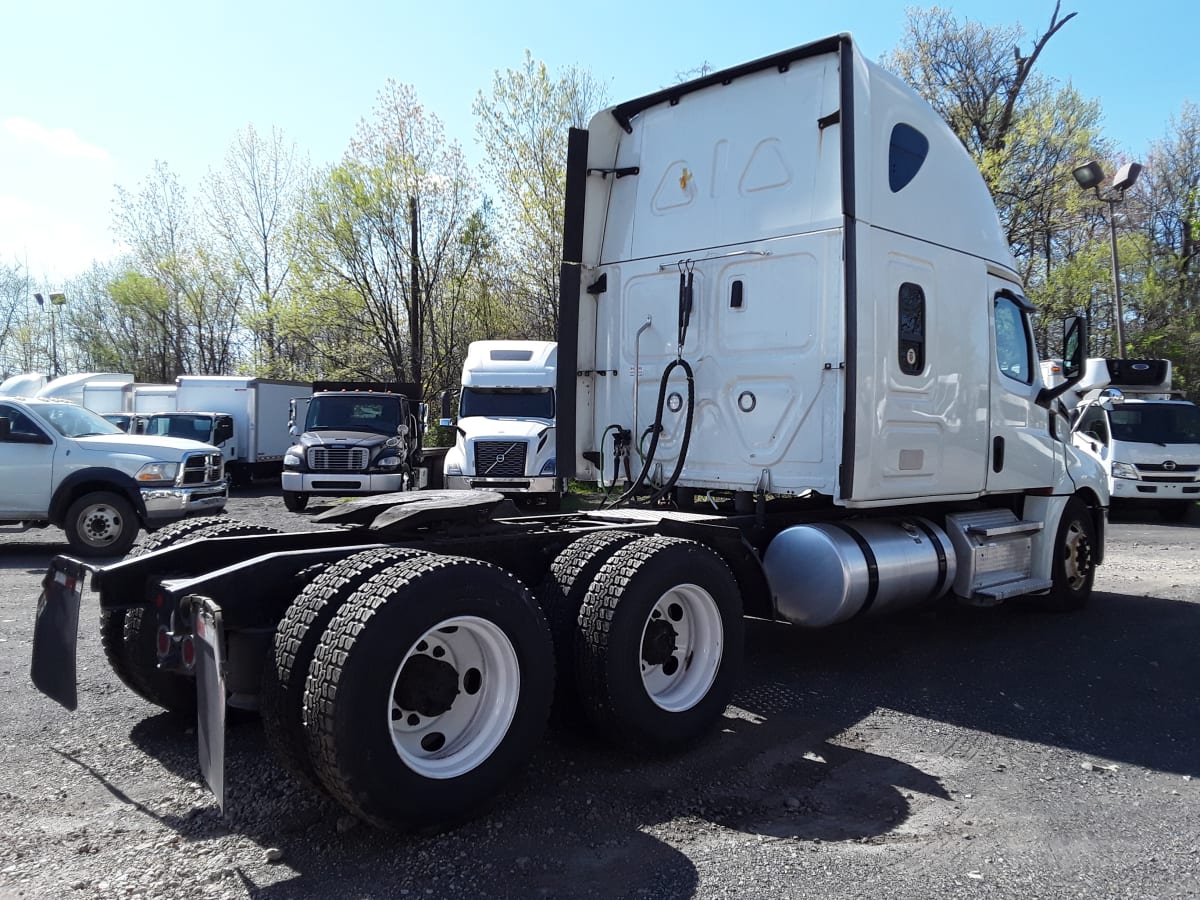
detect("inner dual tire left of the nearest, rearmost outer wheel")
[258,547,427,790]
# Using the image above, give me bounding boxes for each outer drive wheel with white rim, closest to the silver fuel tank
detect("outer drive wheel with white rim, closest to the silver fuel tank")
[576,536,744,752]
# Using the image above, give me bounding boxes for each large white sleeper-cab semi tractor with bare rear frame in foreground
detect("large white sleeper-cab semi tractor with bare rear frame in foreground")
[32,35,1108,828]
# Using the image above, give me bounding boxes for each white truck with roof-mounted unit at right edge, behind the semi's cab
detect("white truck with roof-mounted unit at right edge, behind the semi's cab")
[1072,359,1200,522]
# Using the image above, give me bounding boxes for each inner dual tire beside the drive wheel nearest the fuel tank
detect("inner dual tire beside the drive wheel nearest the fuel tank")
[538,530,640,725]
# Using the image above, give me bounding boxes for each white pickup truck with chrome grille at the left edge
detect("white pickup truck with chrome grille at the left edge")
[0,397,227,556]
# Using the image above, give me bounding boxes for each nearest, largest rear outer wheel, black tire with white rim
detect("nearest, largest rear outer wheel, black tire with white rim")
[305,554,554,828]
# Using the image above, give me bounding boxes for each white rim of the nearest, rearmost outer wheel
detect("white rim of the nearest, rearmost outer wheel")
[388,616,521,779]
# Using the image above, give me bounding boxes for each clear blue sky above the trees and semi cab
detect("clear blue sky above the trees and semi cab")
[0,0,1200,282]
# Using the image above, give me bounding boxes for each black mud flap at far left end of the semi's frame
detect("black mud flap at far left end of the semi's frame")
[30,557,89,709]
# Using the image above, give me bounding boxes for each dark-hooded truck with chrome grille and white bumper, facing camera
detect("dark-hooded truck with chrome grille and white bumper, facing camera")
[282,382,430,512]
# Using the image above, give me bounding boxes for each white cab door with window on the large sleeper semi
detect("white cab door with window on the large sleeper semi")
[986,285,1060,493]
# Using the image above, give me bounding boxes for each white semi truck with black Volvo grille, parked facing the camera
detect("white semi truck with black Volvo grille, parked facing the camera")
[442,341,563,510]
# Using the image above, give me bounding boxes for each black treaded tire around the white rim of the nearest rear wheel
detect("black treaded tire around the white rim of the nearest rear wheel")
[304,554,554,829]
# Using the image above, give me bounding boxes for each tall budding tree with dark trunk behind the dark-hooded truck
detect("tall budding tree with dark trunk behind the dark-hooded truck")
[293,82,475,398]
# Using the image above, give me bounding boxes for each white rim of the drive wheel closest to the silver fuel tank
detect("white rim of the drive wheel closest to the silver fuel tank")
[638,584,725,713]
